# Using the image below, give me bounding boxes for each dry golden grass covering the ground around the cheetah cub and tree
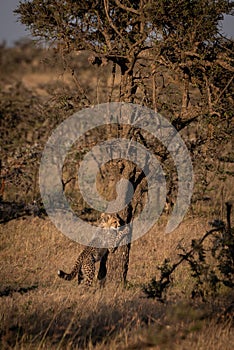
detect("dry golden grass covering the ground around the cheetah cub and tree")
[0,218,234,350]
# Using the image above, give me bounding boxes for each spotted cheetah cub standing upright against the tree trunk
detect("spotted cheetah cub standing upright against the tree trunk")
[58,214,127,286]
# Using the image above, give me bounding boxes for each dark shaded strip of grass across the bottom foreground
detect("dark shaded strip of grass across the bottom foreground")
[0,294,234,350]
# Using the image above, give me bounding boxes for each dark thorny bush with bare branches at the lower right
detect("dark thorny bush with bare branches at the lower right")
[143,203,234,301]
